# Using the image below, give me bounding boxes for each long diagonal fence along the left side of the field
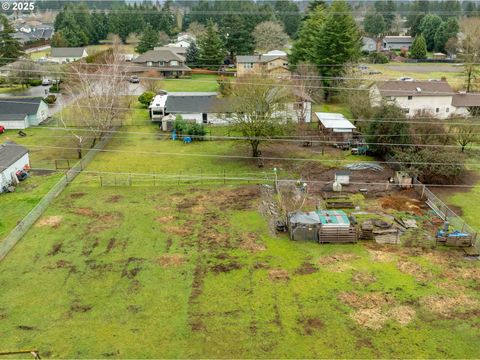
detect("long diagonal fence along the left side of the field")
[0,132,115,261]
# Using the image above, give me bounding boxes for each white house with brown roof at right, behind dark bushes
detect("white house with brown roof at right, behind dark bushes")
[370,80,456,119]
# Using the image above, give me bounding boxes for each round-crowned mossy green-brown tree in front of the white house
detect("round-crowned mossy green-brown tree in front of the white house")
[231,75,292,157]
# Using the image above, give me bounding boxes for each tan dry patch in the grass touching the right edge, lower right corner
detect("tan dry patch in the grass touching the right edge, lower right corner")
[421,294,480,319]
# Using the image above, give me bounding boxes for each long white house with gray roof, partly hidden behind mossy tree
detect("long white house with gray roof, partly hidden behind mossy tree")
[149,92,311,124]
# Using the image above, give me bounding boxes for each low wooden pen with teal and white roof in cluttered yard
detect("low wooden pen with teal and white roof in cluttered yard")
[288,210,357,243]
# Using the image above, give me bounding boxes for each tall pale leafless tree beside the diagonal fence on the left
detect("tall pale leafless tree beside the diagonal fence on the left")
[64,39,128,158]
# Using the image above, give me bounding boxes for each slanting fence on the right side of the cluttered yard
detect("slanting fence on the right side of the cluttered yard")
[413,178,480,248]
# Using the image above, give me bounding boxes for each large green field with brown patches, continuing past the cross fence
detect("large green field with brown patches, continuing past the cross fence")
[0,126,480,358]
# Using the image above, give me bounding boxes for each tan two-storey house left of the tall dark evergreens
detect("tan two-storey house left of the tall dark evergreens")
[237,50,290,77]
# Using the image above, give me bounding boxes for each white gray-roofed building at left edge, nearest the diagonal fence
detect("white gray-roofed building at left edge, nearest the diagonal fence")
[0,141,30,193]
